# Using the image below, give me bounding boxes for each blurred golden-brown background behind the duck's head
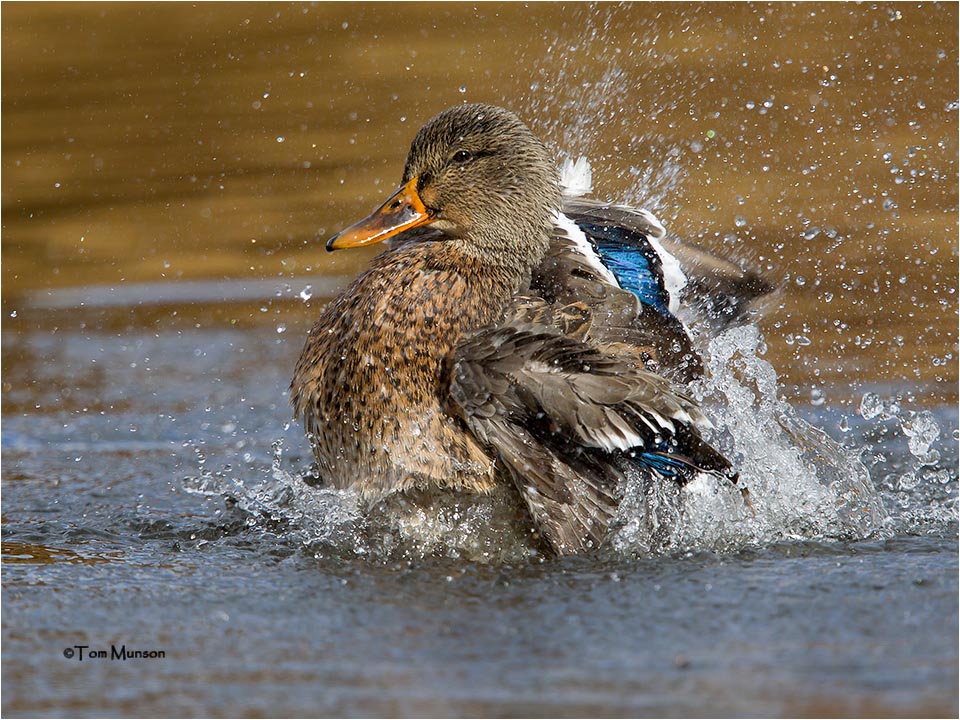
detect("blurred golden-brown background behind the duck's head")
[2,3,958,403]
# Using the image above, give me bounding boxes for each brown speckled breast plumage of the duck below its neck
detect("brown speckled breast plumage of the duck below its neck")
[293,242,517,498]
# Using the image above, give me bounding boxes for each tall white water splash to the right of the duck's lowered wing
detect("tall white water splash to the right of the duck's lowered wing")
[614,326,886,554]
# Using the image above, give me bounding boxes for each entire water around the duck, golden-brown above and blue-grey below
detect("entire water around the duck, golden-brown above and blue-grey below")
[2,4,958,717]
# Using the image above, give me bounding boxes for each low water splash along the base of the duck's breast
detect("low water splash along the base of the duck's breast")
[183,441,538,563]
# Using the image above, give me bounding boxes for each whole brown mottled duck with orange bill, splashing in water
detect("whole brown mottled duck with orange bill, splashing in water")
[290,103,768,555]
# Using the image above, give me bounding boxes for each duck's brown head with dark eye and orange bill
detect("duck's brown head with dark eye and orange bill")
[327,104,560,267]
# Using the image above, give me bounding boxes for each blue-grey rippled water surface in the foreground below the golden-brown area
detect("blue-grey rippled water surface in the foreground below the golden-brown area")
[3,292,957,716]
